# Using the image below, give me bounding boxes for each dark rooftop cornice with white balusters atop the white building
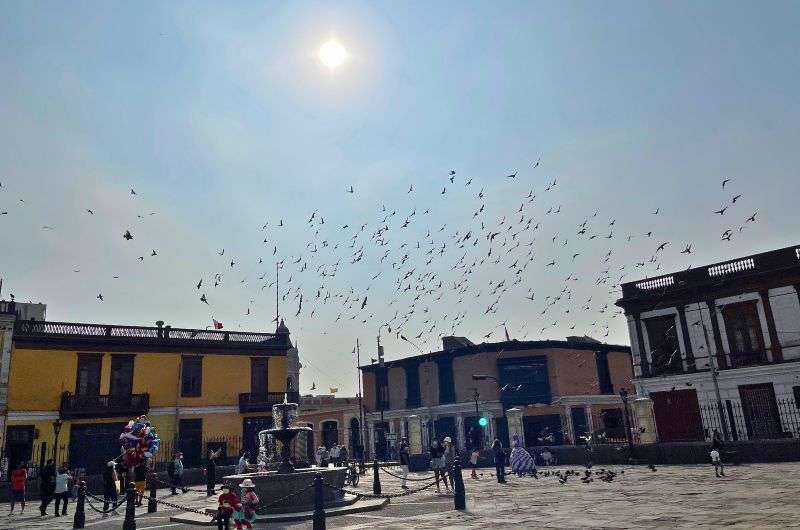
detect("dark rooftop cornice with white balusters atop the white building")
[622,242,800,303]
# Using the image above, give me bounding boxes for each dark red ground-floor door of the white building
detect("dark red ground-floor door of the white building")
[650,390,703,442]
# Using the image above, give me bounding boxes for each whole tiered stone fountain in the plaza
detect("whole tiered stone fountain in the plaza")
[223,397,358,519]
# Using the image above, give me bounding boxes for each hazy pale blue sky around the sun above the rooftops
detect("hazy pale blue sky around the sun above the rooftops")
[0,1,800,393]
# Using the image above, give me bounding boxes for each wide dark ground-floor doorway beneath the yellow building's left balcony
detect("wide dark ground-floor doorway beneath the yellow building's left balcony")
[69,423,125,475]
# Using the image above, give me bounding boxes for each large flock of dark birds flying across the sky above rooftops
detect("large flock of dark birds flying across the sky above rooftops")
[0,165,758,380]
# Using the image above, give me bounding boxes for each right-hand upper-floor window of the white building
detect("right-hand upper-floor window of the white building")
[722,300,766,367]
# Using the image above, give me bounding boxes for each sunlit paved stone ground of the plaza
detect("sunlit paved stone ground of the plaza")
[0,463,800,530]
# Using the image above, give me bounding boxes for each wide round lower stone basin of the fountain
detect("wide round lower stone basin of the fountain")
[222,467,356,515]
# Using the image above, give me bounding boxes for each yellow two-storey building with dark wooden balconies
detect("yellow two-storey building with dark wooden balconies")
[0,303,296,473]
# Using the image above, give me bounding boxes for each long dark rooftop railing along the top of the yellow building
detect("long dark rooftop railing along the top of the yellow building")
[14,320,288,348]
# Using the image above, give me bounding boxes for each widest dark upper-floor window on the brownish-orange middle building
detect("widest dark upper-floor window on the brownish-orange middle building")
[497,356,550,408]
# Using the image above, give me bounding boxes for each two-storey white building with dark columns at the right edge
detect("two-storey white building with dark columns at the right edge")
[617,246,800,441]
